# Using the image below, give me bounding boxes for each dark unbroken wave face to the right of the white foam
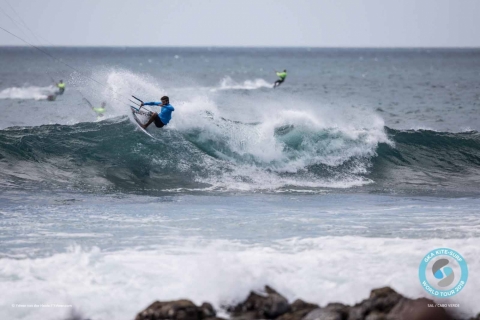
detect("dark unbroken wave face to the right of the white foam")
[368,128,480,192]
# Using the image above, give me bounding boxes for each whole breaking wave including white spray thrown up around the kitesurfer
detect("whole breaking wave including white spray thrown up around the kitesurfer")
[0,70,480,193]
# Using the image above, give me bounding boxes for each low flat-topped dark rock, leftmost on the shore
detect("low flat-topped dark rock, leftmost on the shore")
[135,300,215,320]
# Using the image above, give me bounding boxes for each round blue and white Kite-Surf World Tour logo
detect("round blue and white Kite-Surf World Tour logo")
[418,248,468,298]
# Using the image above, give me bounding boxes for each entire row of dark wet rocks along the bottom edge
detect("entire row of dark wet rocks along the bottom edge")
[135,286,480,320]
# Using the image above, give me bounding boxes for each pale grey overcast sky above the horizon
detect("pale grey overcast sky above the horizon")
[0,0,480,47]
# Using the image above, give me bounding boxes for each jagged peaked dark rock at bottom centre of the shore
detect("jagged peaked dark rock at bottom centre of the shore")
[227,286,290,320]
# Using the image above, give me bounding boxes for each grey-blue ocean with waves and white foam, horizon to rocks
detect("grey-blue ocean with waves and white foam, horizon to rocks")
[0,47,480,320]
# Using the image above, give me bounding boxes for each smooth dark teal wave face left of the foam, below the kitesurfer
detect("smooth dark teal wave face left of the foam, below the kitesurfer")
[0,118,210,191]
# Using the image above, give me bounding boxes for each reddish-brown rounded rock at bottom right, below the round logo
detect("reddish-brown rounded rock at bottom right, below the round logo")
[387,298,453,320]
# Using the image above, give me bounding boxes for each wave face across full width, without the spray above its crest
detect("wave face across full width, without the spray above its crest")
[0,112,480,192]
